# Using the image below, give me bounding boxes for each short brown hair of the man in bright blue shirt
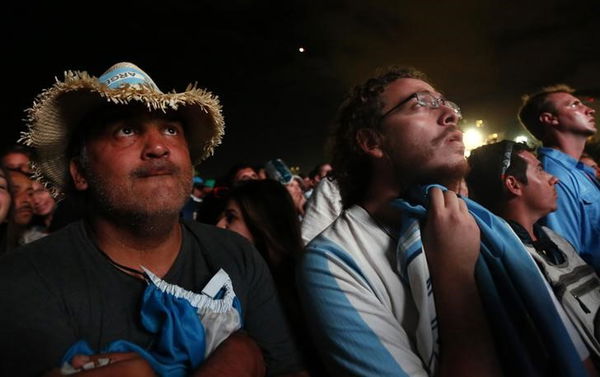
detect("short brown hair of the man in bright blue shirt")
[518,84,575,140]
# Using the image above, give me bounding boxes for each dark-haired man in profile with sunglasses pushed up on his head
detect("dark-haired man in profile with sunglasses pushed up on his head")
[467,140,600,358]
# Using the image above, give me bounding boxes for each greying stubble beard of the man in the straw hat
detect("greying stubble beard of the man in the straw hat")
[86,163,192,235]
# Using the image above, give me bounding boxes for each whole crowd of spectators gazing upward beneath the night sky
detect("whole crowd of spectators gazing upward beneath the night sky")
[0,63,600,376]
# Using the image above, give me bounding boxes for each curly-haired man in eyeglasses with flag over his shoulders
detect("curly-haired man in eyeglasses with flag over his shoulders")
[298,68,585,376]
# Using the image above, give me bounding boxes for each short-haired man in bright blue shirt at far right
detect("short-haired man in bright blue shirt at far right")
[519,85,600,271]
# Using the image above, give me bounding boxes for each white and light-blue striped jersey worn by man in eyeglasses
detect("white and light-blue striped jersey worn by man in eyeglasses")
[297,206,430,377]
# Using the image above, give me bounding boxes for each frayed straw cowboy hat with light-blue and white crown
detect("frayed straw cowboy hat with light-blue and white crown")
[21,63,224,194]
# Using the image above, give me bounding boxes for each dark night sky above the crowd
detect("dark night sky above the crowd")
[1,0,600,176]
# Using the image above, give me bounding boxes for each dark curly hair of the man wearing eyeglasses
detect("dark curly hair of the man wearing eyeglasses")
[330,66,429,208]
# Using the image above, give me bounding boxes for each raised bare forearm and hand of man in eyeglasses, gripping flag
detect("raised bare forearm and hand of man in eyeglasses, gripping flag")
[423,189,502,376]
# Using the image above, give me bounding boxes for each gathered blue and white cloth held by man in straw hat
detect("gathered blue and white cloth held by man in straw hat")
[62,269,242,377]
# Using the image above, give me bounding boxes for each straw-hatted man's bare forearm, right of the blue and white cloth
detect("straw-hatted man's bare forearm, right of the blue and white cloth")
[193,333,265,377]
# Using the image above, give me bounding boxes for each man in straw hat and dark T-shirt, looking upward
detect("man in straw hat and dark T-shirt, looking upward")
[0,63,302,376]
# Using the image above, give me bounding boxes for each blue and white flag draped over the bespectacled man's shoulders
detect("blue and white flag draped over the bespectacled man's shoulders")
[392,185,587,376]
